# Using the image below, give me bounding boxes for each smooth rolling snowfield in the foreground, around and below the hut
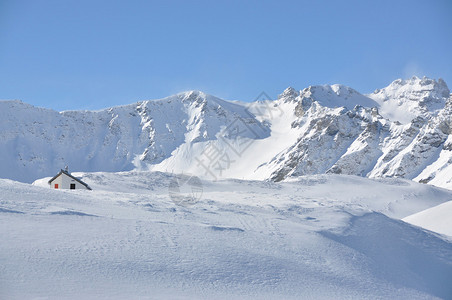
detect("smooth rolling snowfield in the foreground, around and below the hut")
[0,172,452,299]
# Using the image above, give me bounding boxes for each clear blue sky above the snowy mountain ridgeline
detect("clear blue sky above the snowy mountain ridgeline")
[0,0,452,110]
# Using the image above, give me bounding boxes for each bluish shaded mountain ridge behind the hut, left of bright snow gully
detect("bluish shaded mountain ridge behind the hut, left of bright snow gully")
[0,91,269,182]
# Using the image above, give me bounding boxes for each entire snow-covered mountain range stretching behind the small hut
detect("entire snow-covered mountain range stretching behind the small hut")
[0,77,452,188]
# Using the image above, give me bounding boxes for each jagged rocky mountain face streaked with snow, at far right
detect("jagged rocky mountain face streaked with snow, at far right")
[269,77,452,186]
